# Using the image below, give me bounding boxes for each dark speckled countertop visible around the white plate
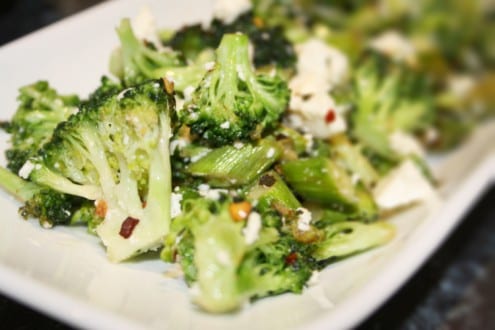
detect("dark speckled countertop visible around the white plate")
[0,0,495,330]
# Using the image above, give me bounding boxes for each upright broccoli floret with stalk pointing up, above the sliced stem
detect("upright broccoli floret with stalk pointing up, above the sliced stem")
[178,34,289,146]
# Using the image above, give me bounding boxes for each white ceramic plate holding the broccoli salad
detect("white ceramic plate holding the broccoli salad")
[0,0,495,329]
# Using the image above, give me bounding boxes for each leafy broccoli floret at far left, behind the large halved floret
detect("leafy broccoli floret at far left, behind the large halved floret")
[1,81,79,173]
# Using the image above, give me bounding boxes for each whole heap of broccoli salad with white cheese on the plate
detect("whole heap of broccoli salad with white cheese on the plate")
[0,0,495,313]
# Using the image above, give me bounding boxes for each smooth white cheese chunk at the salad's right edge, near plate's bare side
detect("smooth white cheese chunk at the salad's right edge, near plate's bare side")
[373,159,436,210]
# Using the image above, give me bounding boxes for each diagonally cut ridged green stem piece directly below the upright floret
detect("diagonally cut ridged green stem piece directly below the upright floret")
[187,139,281,187]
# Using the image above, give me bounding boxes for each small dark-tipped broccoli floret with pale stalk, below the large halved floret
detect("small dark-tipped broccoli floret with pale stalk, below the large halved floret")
[0,167,99,228]
